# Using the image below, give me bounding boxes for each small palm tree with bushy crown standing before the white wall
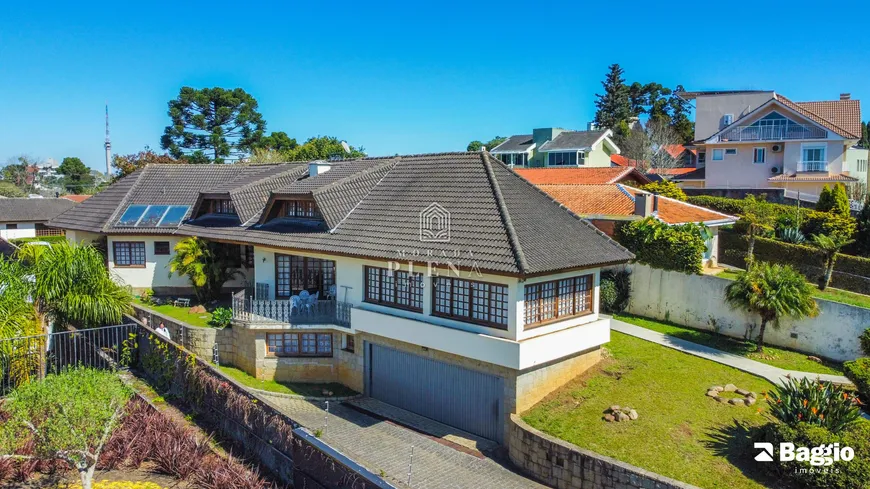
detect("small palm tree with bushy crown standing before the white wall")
[725,262,819,353]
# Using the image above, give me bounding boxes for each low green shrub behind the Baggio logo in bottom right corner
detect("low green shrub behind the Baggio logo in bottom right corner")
[752,420,870,489]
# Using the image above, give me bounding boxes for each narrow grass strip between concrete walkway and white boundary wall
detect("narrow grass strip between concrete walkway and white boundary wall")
[613,314,843,375]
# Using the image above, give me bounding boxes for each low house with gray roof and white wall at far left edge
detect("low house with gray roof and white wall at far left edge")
[0,198,76,240]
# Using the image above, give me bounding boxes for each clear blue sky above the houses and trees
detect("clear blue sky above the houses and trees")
[0,0,870,169]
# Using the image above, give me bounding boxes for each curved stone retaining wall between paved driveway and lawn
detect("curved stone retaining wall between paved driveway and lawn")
[508,414,698,489]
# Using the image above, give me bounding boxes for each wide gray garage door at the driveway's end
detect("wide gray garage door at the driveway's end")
[366,343,504,442]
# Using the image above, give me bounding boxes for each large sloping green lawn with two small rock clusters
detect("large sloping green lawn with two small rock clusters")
[523,331,777,489]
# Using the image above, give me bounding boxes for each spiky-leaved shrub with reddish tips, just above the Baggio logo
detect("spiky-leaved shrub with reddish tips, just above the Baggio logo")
[766,377,861,432]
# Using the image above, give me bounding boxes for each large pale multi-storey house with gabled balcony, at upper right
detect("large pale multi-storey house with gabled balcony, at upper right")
[679,90,861,194]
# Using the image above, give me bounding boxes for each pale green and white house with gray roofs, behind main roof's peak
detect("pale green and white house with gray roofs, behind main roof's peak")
[490,127,619,168]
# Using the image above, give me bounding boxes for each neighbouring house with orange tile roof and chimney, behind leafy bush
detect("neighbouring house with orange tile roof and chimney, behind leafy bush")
[538,184,737,267]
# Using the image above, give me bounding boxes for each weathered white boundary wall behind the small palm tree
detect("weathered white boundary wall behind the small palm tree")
[627,263,870,361]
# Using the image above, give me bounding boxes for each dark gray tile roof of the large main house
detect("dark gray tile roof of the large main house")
[49,152,633,276]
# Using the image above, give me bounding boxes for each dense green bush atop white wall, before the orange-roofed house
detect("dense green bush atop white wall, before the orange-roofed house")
[616,217,709,274]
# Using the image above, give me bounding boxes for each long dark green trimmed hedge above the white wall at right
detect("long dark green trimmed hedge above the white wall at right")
[719,230,870,294]
